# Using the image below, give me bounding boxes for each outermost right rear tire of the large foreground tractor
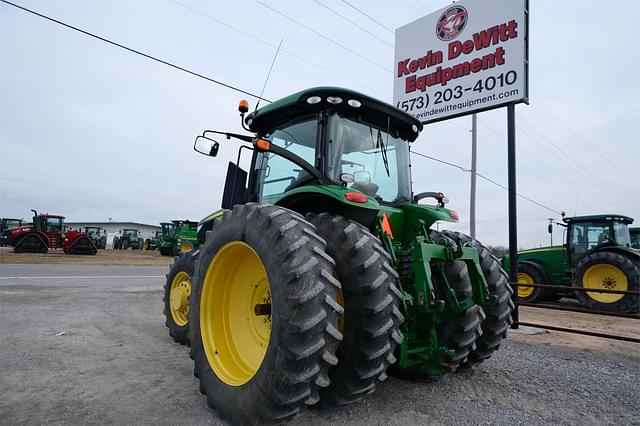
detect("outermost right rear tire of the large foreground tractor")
[443,231,514,367]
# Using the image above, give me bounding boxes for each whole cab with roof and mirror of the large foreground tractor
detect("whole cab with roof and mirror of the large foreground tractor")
[194,87,428,223]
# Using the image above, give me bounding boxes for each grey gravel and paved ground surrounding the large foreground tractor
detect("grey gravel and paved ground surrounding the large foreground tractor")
[0,264,640,425]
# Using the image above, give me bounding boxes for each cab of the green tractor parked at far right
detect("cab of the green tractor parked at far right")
[564,215,633,265]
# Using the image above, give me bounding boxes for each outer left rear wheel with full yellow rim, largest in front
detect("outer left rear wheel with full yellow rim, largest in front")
[189,204,342,424]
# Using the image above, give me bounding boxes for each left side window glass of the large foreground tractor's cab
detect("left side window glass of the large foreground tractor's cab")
[256,116,318,199]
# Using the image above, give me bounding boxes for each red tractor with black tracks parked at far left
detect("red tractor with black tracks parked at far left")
[4,210,98,255]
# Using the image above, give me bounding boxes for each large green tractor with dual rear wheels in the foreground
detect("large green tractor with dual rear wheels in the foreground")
[165,87,513,424]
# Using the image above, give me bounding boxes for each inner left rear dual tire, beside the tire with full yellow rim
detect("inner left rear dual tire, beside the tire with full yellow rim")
[307,213,404,406]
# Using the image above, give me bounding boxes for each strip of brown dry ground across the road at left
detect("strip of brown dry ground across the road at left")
[0,247,173,266]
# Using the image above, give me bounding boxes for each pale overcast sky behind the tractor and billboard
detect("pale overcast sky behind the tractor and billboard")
[0,0,640,247]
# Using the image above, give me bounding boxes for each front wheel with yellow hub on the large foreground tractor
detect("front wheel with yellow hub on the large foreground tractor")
[162,252,198,345]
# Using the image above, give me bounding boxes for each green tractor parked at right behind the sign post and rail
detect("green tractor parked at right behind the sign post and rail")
[516,214,640,313]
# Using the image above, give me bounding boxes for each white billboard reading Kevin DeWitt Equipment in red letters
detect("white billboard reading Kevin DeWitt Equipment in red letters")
[393,0,529,123]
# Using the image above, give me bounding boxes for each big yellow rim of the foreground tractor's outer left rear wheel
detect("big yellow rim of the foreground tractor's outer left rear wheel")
[200,241,271,386]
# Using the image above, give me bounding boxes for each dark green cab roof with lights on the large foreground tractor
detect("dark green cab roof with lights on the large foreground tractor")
[245,86,422,141]
